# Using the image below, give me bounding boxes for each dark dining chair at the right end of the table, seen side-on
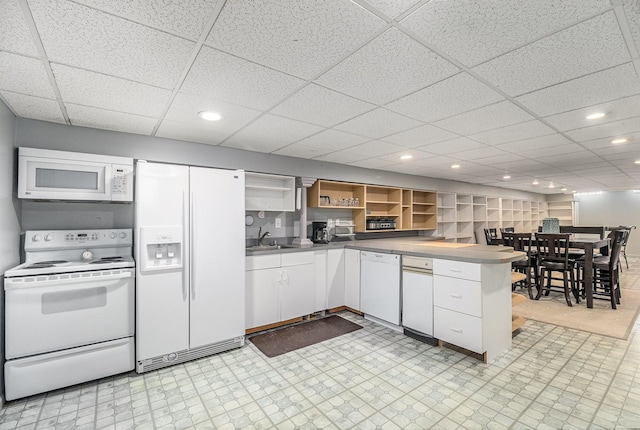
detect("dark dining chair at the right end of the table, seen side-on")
[577,229,630,309]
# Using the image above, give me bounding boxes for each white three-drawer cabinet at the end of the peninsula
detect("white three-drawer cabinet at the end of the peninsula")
[433,259,511,362]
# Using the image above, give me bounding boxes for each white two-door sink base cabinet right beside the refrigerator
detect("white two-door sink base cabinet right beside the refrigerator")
[245,252,315,329]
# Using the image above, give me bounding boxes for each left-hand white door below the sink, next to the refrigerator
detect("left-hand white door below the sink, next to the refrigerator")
[245,268,282,328]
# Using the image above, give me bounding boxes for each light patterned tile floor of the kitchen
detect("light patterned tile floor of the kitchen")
[0,259,640,430]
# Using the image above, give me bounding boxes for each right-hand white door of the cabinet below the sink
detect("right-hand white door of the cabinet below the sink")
[280,264,315,321]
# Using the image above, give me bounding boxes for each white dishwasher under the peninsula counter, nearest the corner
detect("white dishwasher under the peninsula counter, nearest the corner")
[360,251,400,326]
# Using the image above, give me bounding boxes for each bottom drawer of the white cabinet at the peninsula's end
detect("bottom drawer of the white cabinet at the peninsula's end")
[433,306,484,354]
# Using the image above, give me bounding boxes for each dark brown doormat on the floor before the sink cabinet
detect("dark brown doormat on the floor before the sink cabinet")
[249,315,362,357]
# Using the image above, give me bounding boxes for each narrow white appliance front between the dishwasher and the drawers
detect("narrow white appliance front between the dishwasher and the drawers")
[402,255,436,345]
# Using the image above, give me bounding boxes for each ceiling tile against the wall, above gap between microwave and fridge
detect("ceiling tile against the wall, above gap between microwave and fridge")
[65,103,157,135]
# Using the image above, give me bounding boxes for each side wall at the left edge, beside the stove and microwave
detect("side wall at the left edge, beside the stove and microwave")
[0,101,20,407]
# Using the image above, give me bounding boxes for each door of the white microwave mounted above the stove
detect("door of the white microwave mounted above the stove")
[18,156,111,201]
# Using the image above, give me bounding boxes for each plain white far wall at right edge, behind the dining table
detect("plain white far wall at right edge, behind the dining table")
[576,190,640,256]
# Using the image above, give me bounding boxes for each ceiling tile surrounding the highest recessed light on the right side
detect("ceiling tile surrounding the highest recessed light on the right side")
[545,94,640,131]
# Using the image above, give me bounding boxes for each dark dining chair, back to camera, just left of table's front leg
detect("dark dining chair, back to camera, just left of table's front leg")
[535,233,580,306]
